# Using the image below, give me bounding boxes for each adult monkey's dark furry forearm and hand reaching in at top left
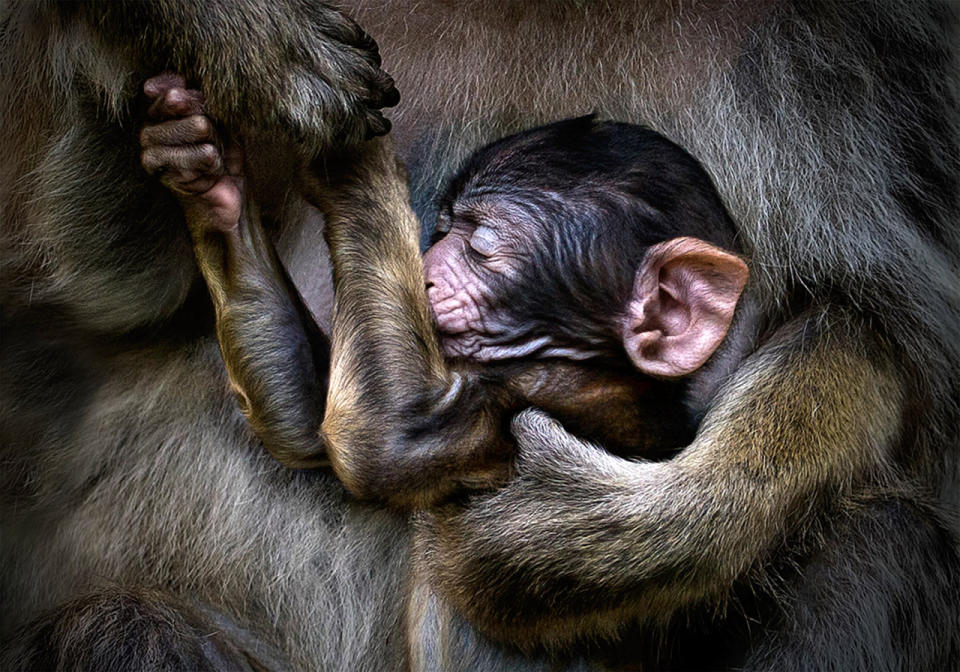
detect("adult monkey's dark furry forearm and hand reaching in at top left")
[82,0,399,154]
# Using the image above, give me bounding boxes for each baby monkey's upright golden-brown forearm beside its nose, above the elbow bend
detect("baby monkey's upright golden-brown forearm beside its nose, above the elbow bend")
[324,168,453,412]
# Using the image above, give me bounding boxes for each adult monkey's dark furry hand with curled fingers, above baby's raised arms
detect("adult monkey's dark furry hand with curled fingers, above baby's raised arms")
[189,3,400,150]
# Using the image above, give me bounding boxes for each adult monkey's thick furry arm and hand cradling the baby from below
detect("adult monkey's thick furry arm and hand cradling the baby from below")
[417,316,903,646]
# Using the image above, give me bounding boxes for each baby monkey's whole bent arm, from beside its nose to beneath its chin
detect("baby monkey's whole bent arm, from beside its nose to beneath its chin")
[308,140,682,507]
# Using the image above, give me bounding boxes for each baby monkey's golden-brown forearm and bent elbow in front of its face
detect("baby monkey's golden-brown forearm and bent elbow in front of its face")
[306,140,510,507]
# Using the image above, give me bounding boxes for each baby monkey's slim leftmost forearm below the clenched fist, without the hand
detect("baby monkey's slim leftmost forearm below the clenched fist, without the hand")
[187,198,329,467]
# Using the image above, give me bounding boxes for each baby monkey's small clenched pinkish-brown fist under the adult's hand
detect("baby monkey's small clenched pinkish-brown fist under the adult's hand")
[140,74,249,231]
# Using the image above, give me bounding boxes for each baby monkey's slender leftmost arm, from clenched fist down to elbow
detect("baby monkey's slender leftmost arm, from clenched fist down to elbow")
[140,75,329,467]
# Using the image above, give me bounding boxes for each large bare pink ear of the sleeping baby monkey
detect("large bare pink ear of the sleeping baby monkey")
[623,238,749,378]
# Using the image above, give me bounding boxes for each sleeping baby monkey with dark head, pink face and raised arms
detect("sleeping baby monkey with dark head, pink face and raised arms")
[142,78,748,507]
